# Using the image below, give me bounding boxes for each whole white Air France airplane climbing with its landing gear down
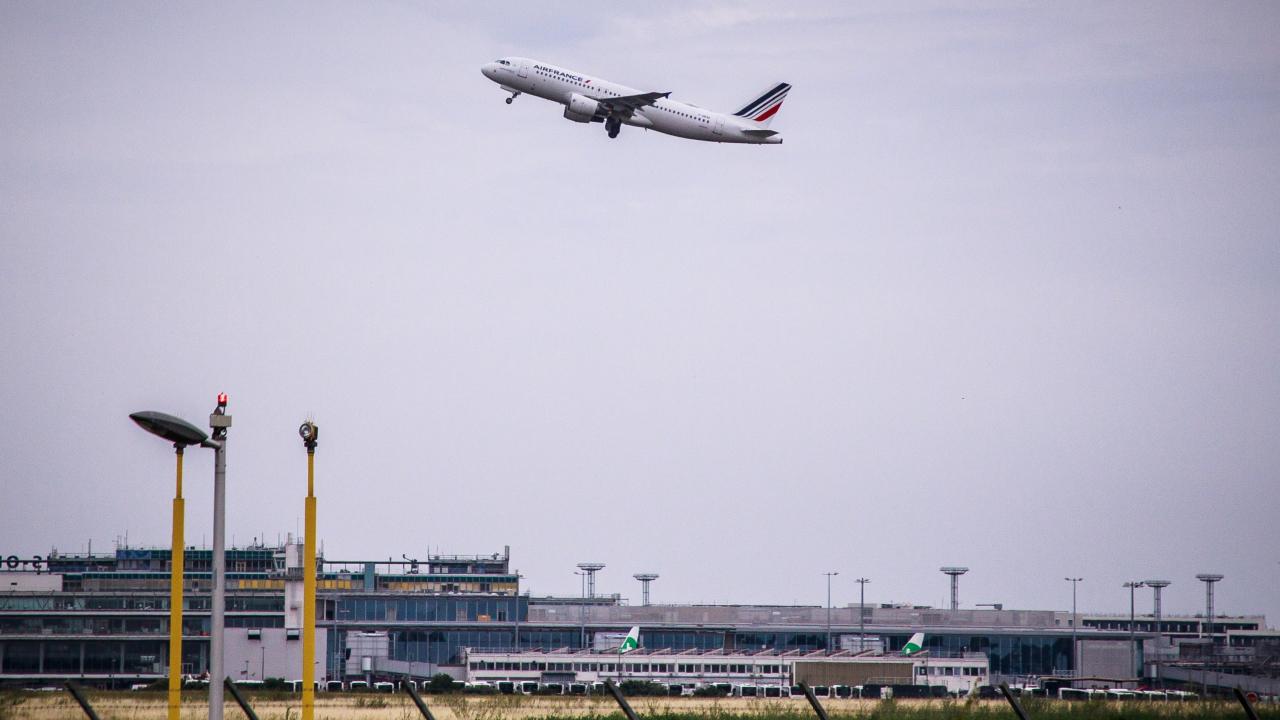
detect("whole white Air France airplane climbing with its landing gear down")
[480,58,791,145]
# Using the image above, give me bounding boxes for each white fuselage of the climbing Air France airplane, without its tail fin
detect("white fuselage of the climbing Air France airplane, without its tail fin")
[480,58,782,145]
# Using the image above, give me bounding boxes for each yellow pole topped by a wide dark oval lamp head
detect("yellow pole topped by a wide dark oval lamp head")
[129,411,209,720]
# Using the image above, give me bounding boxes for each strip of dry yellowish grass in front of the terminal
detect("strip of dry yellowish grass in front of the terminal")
[0,692,1280,720]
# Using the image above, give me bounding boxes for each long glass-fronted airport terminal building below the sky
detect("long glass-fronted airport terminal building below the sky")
[0,542,1280,687]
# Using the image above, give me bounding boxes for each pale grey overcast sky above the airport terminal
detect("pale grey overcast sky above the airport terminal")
[0,1,1280,625]
